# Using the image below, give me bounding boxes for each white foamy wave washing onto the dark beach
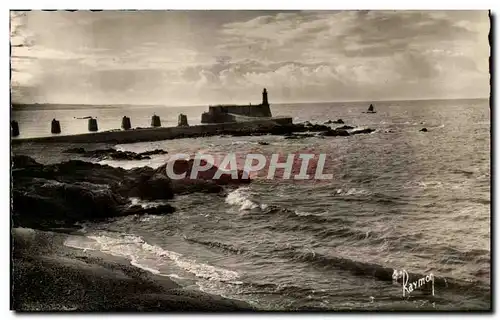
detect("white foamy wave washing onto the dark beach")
[65,235,239,282]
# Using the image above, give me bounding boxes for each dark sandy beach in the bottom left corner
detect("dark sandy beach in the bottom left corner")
[11,228,256,312]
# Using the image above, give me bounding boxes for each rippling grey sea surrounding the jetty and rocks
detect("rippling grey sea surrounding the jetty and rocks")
[11,99,491,311]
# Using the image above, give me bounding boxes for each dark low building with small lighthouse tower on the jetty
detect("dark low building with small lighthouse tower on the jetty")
[201,88,272,123]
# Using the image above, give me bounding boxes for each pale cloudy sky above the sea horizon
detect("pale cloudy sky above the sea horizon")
[11,11,490,106]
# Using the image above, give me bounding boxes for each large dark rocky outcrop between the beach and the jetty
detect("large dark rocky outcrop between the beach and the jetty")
[12,156,250,228]
